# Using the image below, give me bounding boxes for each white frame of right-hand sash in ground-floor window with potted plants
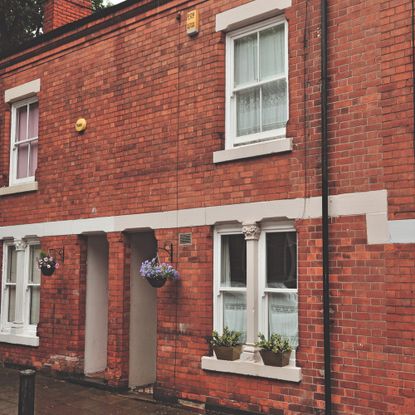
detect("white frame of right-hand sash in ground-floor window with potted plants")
[258,224,298,342]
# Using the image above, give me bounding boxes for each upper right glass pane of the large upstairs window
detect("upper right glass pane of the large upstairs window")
[259,25,285,80]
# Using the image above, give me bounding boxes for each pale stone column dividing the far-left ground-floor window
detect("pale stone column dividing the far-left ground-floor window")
[10,239,27,334]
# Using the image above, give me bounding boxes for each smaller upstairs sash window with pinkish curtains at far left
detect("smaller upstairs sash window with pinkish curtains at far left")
[10,97,39,185]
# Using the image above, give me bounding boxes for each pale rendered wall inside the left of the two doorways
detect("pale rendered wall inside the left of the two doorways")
[85,236,108,374]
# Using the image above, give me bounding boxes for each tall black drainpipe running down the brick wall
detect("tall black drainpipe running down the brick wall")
[321,0,331,415]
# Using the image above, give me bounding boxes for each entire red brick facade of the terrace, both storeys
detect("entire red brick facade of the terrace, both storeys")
[0,0,415,415]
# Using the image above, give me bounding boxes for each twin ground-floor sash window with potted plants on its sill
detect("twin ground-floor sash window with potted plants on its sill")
[214,223,298,348]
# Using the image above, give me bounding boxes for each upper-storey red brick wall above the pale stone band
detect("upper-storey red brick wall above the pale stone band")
[0,0,414,224]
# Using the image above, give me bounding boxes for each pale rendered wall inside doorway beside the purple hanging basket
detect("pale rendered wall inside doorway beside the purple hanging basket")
[128,232,157,388]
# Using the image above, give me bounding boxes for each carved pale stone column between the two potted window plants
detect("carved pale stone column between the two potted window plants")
[241,223,261,362]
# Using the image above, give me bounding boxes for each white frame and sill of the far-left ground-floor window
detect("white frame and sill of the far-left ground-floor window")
[0,239,41,346]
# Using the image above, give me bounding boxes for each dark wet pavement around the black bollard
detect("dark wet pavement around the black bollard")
[0,368,194,415]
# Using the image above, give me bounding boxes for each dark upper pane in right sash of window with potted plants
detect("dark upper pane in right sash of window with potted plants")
[266,232,297,288]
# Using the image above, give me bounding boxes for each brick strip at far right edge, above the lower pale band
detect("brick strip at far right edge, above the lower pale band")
[379,0,415,219]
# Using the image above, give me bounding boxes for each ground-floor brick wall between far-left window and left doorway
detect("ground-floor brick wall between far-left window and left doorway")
[0,236,86,373]
